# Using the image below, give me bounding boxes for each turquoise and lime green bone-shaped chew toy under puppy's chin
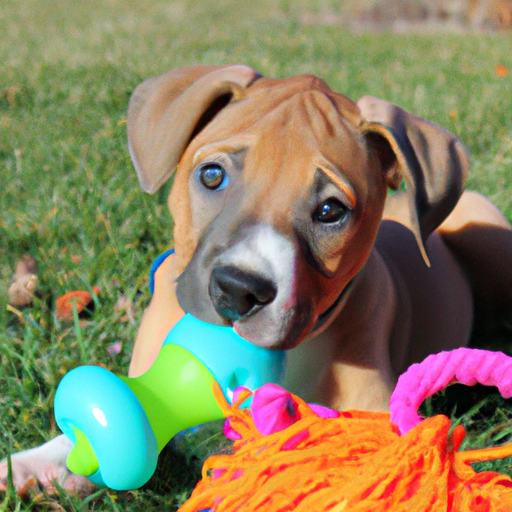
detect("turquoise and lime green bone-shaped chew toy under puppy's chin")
[55,314,285,490]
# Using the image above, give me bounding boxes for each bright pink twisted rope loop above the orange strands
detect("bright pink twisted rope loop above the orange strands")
[389,348,512,435]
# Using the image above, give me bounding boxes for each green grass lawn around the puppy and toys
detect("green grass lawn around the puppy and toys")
[0,0,512,511]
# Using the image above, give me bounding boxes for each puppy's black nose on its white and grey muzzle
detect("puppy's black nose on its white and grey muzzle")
[210,266,277,322]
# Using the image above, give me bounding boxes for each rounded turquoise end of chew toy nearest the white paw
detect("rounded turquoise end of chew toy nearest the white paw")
[54,366,158,489]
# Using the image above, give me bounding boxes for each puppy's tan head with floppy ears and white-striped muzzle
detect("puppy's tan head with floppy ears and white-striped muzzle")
[128,66,468,348]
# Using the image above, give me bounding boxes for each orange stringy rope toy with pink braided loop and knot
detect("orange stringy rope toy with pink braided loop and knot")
[179,348,512,512]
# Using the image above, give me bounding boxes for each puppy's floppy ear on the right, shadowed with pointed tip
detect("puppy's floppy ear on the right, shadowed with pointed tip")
[357,96,470,266]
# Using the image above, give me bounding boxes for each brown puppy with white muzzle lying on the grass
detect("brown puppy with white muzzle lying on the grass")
[0,66,512,489]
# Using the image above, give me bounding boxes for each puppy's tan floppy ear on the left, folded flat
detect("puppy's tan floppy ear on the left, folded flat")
[128,65,260,194]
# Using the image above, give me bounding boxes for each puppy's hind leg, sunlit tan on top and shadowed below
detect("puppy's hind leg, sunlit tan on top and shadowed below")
[439,192,512,344]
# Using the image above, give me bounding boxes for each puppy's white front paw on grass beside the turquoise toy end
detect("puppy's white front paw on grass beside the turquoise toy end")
[0,436,96,497]
